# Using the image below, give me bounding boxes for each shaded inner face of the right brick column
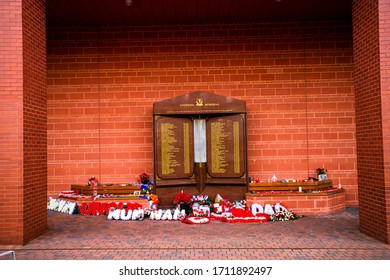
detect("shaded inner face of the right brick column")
[353,1,389,241]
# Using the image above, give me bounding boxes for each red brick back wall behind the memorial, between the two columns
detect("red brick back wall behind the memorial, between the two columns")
[47,22,357,205]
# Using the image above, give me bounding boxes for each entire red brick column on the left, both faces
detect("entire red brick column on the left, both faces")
[0,0,47,245]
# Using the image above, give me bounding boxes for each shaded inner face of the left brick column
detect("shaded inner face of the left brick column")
[23,0,47,243]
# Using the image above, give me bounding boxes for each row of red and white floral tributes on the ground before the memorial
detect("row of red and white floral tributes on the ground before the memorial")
[47,185,302,224]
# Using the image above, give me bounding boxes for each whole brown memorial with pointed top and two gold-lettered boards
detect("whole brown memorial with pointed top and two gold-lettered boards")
[153,91,248,206]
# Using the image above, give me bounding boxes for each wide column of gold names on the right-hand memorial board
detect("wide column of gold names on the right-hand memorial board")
[211,122,228,173]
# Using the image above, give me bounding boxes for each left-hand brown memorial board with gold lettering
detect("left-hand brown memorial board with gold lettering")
[155,116,194,180]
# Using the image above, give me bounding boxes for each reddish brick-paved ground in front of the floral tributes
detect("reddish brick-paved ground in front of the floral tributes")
[0,208,390,260]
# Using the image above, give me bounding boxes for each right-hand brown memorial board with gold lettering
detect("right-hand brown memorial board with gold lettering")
[206,114,246,178]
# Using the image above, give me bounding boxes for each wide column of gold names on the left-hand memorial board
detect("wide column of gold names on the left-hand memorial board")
[161,123,180,175]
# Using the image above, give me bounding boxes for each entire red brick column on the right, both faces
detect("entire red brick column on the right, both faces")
[352,0,390,243]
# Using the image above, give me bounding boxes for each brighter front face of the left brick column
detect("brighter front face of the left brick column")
[0,0,23,244]
